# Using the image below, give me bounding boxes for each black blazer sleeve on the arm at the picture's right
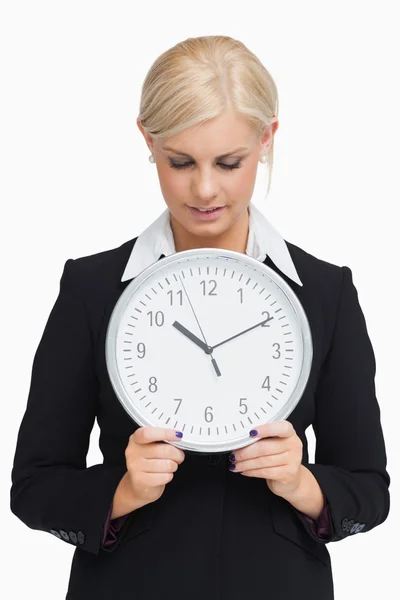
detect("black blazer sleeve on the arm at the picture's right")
[296,266,390,543]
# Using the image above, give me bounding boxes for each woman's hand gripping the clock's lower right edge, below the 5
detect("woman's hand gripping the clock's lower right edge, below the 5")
[232,421,304,499]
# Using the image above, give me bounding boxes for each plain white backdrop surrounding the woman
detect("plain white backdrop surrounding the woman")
[0,0,400,600]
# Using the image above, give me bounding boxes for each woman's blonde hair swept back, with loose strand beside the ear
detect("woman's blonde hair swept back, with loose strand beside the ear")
[138,35,278,199]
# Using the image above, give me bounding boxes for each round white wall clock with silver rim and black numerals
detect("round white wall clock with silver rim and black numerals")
[106,248,312,453]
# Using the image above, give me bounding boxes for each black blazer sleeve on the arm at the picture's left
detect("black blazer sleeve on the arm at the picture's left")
[10,259,132,555]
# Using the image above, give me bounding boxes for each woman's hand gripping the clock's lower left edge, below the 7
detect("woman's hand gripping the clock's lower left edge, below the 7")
[125,426,185,504]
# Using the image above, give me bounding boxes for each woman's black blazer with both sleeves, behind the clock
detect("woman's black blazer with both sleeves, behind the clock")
[10,237,390,600]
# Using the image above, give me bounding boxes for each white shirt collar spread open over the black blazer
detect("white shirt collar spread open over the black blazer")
[121,202,303,285]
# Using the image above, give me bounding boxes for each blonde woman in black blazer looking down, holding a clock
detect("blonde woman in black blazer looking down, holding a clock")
[11,36,390,600]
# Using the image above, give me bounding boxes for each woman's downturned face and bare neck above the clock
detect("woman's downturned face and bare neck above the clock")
[137,112,278,252]
